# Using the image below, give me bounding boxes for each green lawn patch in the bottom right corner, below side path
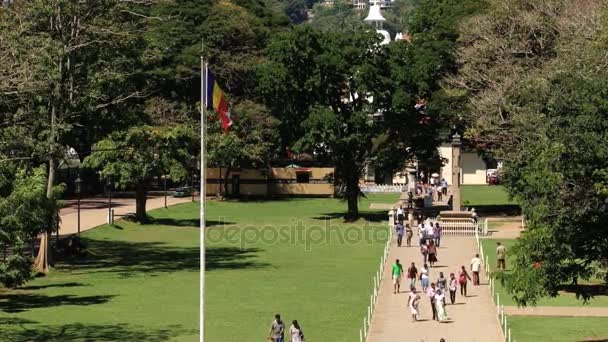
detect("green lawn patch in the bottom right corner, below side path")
[508,316,608,342]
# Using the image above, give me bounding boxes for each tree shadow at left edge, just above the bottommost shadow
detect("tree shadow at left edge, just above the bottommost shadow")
[0,291,115,313]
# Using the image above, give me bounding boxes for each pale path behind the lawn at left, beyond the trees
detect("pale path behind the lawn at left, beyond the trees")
[59,196,192,235]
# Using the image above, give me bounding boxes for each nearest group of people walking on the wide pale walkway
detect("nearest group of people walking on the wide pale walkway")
[392,250,481,322]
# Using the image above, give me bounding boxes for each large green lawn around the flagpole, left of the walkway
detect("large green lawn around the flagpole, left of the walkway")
[0,194,399,341]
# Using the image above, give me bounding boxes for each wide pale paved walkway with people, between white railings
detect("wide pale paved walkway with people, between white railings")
[367,236,504,342]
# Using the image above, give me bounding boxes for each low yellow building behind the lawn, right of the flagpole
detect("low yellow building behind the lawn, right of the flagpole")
[205,167,334,197]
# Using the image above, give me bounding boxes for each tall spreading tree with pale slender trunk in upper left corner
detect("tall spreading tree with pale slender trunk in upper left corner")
[0,0,159,271]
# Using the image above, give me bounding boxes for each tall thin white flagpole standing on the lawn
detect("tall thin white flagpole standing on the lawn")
[199,56,207,342]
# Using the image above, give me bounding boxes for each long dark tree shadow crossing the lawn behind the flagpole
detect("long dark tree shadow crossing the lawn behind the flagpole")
[56,239,268,278]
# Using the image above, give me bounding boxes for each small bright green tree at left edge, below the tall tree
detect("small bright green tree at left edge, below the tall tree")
[0,167,62,288]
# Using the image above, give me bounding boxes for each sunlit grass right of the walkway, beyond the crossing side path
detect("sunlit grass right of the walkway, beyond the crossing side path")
[481,239,608,307]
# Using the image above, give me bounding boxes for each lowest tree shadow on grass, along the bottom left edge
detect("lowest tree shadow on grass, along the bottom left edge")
[0,320,197,342]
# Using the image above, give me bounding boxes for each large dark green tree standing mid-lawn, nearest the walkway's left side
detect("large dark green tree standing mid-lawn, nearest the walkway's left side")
[259,26,388,219]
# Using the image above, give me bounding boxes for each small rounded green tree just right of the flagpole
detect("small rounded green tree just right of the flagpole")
[207,101,279,195]
